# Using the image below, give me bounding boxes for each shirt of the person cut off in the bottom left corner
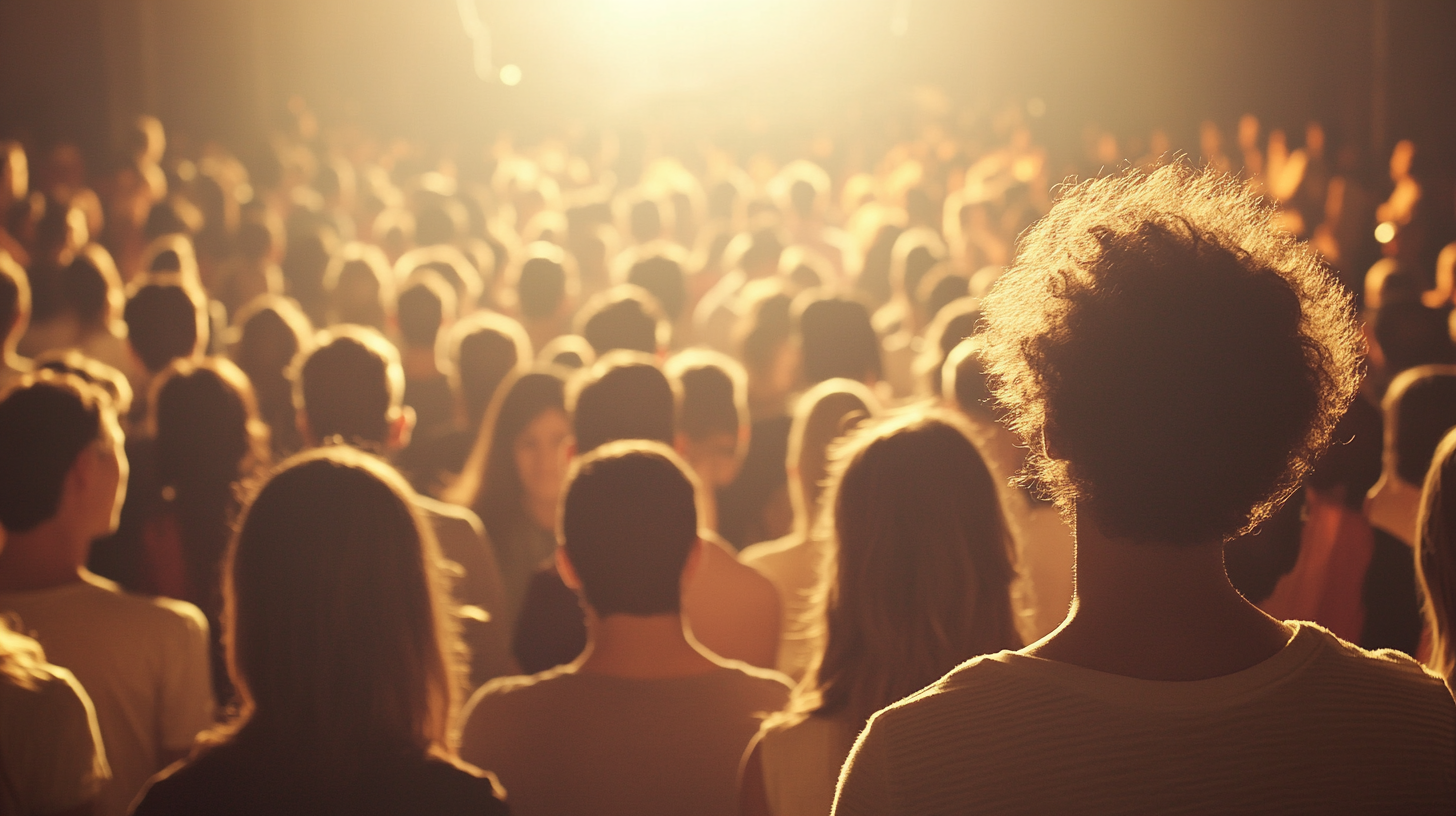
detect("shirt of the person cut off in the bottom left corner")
[0,646,111,813]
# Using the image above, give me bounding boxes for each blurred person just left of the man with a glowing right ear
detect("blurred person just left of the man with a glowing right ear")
[230,294,313,459]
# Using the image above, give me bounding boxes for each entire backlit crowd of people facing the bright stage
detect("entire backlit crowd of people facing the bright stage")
[0,96,1456,816]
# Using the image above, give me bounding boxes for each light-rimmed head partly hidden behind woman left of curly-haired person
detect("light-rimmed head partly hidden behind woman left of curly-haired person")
[785,377,879,535]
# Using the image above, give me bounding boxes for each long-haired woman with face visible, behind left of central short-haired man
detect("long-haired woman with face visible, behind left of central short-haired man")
[447,369,572,644]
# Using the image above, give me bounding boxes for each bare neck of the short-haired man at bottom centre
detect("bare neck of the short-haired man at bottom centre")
[577,609,719,679]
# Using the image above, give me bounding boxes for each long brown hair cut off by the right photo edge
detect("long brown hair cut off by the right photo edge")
[1415,430,1456,678]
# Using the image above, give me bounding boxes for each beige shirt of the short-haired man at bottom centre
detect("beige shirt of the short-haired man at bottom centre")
[460,662,789,816]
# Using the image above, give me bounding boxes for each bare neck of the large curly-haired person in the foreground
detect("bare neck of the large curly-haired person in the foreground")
[1026,511,1290,680]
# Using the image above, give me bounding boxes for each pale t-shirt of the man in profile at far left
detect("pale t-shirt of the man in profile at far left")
[0,574,215,816]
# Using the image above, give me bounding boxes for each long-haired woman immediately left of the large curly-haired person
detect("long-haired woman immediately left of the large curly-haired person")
[741,412,1022,816]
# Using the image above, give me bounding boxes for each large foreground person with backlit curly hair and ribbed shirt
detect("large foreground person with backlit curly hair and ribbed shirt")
[834,165,1456,816]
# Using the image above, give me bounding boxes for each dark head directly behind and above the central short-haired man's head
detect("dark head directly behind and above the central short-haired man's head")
[566,351,677,453]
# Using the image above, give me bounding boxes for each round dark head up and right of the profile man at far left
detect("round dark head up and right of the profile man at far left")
[122,275,207,374]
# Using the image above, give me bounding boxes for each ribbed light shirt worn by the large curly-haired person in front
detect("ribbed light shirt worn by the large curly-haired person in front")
[834,622,1456,816]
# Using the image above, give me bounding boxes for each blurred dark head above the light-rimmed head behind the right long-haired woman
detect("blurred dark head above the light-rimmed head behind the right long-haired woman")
[794,291,884,385]
